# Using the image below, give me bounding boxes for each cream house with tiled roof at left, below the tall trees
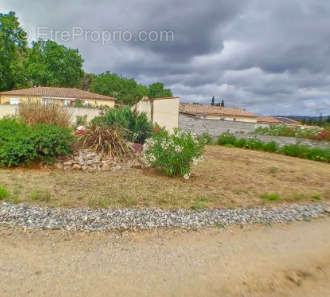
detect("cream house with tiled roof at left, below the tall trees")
[0,87,116,108]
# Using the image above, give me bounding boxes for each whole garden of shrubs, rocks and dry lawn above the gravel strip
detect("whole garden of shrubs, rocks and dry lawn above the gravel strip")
[0,104,330,211]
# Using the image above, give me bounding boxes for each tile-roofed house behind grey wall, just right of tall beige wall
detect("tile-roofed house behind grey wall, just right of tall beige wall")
[179,103,257,123]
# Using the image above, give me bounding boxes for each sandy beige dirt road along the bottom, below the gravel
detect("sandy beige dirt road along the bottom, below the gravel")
[0,219,330,297]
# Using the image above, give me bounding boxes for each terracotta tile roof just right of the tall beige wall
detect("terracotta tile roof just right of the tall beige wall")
[180,103,257,118]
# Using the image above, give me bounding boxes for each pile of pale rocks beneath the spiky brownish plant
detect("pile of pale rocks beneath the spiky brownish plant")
[55,149,145,171]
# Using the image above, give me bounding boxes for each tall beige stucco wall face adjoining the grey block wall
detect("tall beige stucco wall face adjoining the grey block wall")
[153,98,180,132]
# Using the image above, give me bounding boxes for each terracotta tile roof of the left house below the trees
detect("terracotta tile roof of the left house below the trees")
[0,87,116,101]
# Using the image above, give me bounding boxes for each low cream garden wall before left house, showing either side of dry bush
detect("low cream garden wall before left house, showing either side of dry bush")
[0,104,101,123]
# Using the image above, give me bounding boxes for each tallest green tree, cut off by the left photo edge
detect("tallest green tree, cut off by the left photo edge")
[0,12,27,90]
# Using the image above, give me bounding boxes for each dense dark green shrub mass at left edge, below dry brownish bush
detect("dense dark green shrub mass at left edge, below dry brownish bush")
[0,119,74,167]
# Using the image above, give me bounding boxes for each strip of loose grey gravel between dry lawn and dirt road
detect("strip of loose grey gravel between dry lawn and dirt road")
[0,203,329,232]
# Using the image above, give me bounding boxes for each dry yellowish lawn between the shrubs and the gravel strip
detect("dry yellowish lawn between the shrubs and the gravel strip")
[0,146,330,209]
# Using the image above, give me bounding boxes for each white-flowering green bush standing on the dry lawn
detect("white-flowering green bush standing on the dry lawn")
[144,130,205,179]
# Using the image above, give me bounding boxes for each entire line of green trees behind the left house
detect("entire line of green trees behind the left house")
[0,12,172,105]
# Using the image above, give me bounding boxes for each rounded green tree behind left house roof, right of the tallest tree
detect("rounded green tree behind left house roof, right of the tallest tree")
[25,40,84,87]
